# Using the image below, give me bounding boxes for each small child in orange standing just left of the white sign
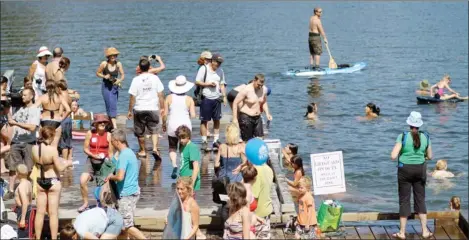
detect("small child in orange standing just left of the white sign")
[295,177,317,239]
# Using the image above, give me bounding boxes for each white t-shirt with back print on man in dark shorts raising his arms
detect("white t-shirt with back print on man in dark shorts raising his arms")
[129,73,164,111]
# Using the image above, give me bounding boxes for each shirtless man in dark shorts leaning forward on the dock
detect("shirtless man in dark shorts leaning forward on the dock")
[233,74,272,142]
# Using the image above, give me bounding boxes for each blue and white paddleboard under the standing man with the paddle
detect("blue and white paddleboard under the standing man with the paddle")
[286,62,366,77]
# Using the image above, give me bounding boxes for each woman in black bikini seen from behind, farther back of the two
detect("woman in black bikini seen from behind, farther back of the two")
[36,80,71,146]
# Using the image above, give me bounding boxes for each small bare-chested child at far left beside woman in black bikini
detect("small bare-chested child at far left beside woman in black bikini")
[15,164,34,229]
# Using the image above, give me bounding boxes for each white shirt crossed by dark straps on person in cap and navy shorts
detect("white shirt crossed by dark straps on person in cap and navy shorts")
[195,64,226,99]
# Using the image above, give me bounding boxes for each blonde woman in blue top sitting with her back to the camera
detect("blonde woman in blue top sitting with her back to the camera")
[215,123,247,183]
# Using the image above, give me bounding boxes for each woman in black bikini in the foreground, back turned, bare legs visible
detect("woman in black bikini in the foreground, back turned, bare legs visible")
[32,126,72,239]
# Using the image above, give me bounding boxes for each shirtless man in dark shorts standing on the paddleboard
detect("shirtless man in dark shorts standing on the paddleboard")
[308,7,327,70]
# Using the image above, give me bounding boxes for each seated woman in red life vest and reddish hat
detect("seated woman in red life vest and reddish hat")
[78,114,114,212]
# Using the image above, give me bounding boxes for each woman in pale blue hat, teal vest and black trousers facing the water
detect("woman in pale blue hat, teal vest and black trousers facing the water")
[391,112,433,239]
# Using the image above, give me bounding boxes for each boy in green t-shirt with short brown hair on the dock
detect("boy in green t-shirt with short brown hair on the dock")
[176,125,200,191]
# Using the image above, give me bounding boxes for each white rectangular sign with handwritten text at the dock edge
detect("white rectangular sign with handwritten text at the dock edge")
[311,151,346,195]
